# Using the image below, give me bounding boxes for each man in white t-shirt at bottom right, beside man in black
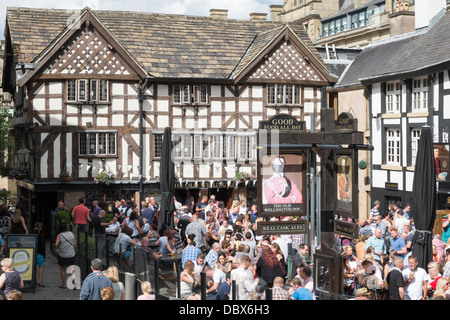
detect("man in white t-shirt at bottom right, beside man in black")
[402,256,428,300]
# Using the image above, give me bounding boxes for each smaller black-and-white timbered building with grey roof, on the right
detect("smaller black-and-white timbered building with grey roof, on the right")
[338,9,450,210]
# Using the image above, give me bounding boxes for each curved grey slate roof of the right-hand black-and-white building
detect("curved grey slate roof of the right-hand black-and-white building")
[337,12,450,87]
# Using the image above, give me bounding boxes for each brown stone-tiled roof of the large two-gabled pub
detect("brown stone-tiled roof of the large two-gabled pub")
[7,8,336,85]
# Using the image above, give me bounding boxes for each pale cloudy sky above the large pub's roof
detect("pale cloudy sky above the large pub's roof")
[0,0,283,39]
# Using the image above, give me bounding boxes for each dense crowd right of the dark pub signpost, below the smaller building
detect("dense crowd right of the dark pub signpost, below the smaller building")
[342,201,450,300]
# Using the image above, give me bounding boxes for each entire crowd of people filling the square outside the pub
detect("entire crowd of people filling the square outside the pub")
[0,195,450,300]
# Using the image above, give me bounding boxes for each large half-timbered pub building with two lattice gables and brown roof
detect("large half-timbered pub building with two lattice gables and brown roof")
[3,8,337,229]
